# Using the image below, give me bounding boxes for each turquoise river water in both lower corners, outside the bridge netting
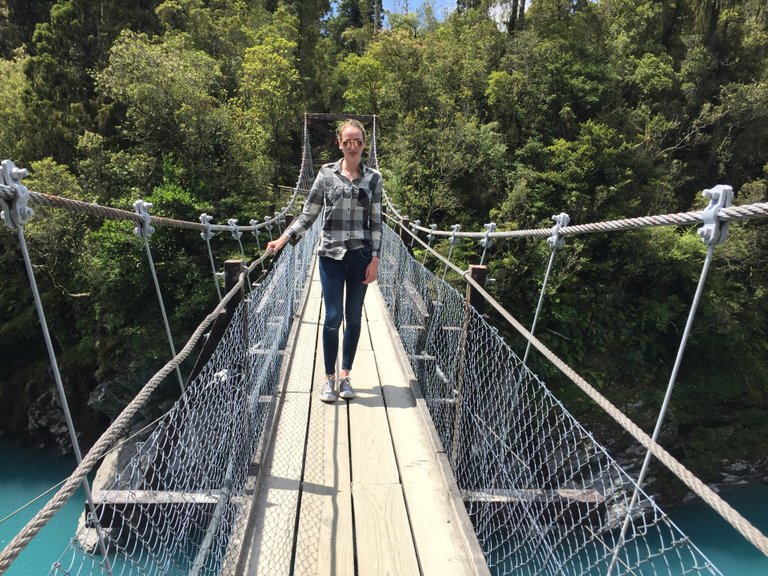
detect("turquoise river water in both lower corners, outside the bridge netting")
[0,441,768,576]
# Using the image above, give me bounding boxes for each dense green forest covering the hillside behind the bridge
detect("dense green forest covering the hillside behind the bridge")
[0,0,768,502]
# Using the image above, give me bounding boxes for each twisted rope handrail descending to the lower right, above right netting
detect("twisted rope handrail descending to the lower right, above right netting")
[389,216,768,556]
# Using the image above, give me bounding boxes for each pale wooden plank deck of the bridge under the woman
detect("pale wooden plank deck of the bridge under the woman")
[239,258,488,576]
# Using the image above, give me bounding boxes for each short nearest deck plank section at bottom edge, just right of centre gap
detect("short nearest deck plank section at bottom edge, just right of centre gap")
[352,481,420,576]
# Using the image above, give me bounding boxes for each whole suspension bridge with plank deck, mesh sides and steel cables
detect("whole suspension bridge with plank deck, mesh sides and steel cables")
[0,115,768,575]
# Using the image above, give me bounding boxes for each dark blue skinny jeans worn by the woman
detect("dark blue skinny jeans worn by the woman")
[320,248,371,375]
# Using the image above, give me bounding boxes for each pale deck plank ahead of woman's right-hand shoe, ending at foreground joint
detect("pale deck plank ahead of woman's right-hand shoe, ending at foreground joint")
[349,350,400,485]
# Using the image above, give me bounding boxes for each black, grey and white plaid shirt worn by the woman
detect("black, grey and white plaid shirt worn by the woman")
[285,160,383,260]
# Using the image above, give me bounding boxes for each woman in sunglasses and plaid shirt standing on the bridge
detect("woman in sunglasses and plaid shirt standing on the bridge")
[267,120,383,402]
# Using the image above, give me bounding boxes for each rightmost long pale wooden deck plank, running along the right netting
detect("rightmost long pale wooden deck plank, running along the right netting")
[366,290,488,574]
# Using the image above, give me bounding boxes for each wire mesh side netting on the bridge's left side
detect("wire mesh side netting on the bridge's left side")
[50,222,317,575]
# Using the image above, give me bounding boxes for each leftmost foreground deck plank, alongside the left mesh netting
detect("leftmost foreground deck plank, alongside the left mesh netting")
[247,393,309,575]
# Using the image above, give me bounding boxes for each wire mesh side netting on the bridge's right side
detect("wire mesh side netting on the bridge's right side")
[379,226,720,575]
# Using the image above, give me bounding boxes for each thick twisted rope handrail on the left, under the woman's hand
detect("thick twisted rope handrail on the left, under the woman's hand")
[0,254,270,574]
